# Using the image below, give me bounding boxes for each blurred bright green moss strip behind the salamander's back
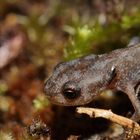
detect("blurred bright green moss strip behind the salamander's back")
[64,7,140,61]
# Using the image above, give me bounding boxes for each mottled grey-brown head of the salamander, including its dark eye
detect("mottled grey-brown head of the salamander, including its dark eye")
[45,55,114,106]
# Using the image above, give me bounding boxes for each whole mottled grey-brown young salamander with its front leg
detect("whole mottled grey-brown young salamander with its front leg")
[45,44,140,121]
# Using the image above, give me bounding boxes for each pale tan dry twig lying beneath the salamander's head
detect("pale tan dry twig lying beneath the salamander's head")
[77,107,140,135]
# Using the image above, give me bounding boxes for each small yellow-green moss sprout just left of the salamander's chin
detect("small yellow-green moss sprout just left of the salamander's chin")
[33,95,49,110]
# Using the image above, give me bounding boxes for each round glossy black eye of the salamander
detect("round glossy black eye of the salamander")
[63,82,81,100]
